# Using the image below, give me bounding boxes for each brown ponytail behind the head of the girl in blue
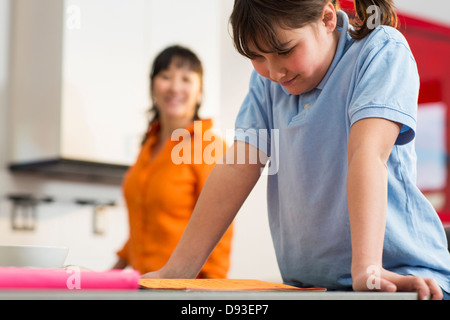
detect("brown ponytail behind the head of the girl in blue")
[350,0,398,40]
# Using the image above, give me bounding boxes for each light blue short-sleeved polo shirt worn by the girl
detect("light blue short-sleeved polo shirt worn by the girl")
[235,12,450,292]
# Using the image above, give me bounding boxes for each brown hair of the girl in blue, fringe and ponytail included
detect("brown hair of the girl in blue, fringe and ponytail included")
[230,0,397,59]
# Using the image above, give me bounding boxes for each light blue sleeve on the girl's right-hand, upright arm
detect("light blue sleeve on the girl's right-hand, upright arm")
[348,30,420,145]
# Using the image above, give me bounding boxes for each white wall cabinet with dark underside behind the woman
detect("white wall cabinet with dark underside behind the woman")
[10,0,220,181]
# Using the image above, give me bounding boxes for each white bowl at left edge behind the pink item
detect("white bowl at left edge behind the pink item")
[0,245,69,269]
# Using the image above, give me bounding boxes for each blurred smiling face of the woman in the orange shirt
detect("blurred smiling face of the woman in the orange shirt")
[152,62,202,121]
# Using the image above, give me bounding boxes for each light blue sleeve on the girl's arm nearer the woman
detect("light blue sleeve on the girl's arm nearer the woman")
[234,71,272,154]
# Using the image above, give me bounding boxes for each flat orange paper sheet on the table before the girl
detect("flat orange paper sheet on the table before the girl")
[139,279,326,291]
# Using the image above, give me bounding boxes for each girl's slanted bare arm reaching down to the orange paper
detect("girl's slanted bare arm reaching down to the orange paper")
[142,142,266,279]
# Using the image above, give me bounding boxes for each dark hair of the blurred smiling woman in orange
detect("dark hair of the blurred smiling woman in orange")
[149,45,203,126]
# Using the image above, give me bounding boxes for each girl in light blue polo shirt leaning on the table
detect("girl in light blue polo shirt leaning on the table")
[144,0,450,299]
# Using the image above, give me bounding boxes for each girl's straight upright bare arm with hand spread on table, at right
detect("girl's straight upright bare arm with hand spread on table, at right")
[347,118,442,299]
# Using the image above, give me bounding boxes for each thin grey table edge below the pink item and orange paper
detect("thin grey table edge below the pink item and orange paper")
[0,289,417,301]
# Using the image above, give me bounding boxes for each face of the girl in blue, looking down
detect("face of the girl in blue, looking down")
[252,11,339,95]
